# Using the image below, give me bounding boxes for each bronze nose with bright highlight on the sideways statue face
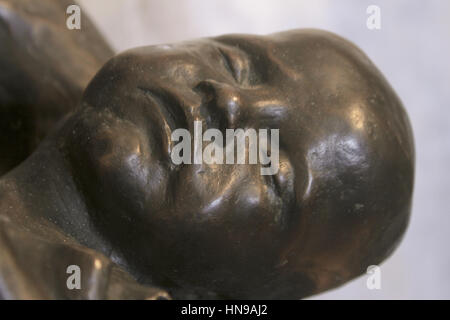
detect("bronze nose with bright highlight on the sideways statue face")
[195,79,244,129]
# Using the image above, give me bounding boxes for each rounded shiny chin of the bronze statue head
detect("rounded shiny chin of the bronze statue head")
[68,115,169,220]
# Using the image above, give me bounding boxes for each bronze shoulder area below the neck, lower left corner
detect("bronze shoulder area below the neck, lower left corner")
[0,216,170,299]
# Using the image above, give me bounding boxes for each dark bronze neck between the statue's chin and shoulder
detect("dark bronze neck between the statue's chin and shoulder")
[0,122,110,256]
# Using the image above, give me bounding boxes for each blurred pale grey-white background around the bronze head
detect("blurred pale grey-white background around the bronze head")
[79,0,450,299]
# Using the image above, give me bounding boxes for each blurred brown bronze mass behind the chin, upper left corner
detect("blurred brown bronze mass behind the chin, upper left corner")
[0,0,113,175]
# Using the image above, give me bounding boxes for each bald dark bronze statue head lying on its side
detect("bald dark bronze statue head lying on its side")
[65,30,414,298]
